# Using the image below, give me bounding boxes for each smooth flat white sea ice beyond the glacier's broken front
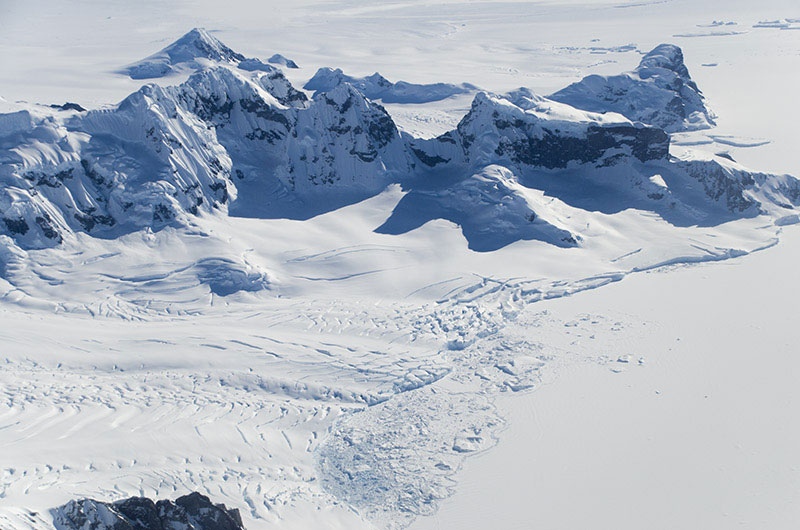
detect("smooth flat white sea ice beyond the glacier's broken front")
[412,230,800,530]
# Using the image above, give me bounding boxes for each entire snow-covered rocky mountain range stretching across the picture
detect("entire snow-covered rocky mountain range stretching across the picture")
[0,39,798,250]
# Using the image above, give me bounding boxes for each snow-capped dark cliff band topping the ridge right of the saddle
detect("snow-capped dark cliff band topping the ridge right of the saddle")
[413,89,669,169]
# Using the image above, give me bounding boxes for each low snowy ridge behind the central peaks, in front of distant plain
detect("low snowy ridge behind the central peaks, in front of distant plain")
[303,68,477,103]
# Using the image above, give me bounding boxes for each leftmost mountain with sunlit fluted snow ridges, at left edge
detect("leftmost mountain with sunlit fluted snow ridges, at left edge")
[0,85,236,248]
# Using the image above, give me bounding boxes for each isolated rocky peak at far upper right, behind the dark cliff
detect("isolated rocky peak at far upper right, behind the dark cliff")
[550,44,714,132]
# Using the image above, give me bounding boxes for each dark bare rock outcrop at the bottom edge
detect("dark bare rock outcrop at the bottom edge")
[53,492,244,530]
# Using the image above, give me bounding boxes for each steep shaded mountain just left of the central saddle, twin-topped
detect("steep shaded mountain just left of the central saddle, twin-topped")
[175,68,410,217]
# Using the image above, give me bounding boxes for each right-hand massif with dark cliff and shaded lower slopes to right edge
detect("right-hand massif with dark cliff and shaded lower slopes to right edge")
[406,85,800,243]
